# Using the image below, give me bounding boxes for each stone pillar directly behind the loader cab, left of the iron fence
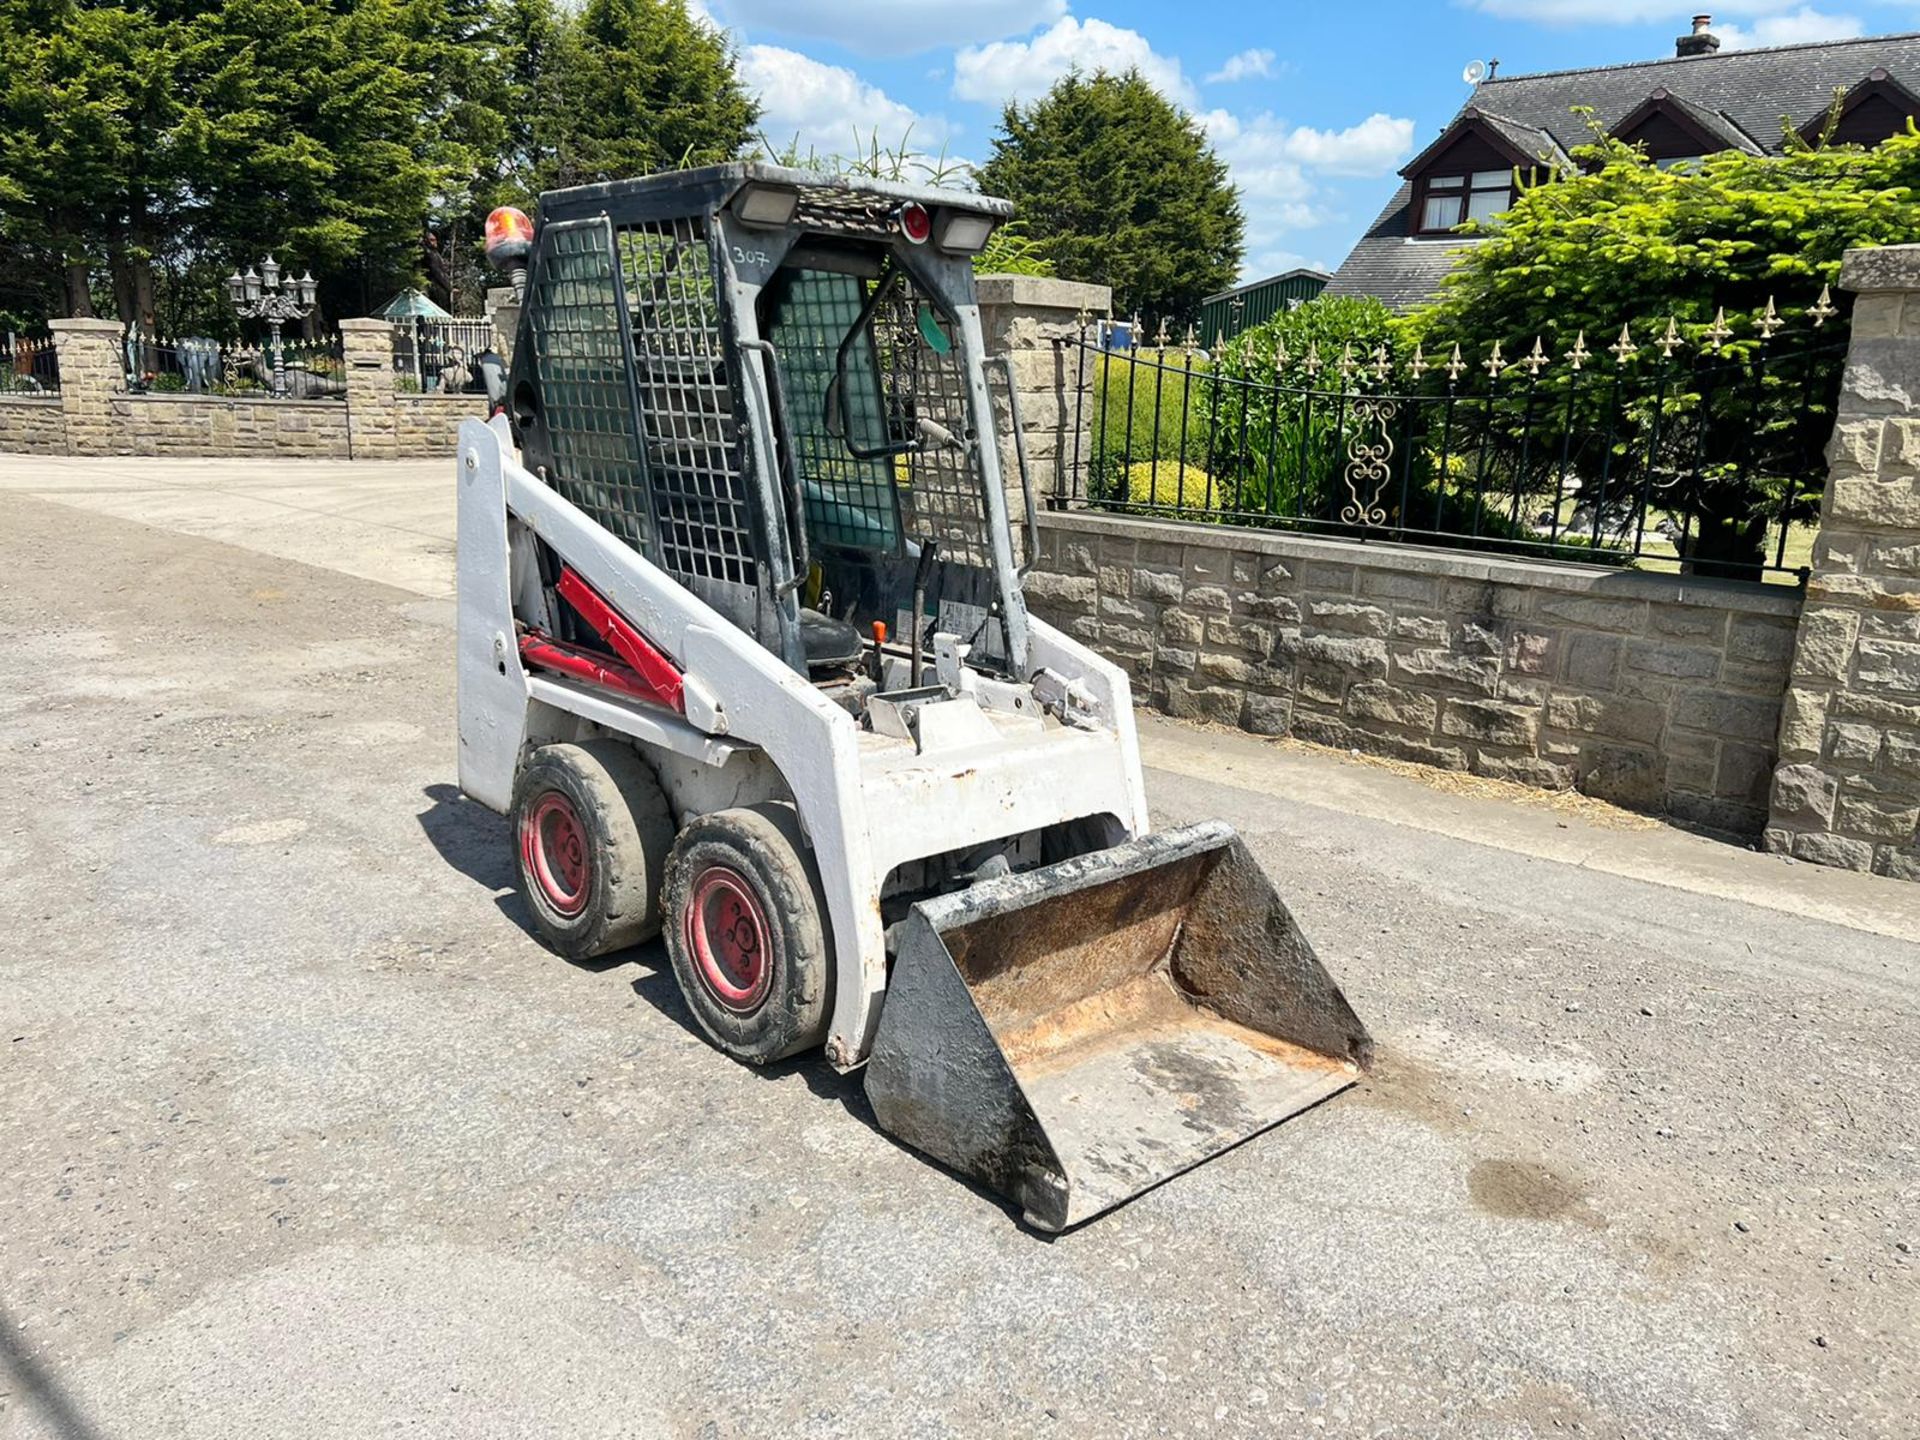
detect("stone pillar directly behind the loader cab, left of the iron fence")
[977,275,1114,553]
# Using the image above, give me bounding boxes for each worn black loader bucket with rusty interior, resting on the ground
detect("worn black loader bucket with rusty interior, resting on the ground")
[866,822,1373,1231]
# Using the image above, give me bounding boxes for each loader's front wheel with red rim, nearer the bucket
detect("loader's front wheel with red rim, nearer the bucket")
[664,803,831,1066]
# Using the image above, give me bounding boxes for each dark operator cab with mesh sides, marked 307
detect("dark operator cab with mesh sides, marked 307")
[509,165,1025,708]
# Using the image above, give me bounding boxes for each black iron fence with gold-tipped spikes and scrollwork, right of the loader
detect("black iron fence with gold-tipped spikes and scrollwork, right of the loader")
[1052,290,1847,584]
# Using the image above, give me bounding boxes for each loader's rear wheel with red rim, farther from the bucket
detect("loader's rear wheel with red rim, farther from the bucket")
[513,739,674,960]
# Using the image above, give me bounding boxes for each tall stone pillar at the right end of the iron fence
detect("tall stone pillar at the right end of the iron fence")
[1766,246,1920,879]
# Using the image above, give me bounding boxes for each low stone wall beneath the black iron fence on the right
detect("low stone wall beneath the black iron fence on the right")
[1027,511,1801,835]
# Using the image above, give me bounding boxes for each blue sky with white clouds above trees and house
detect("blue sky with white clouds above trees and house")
[693,0,1920,278]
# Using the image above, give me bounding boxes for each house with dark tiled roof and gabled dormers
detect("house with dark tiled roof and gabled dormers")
[1325,15,1920,309]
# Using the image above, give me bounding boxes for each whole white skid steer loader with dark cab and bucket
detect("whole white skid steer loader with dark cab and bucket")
[459,165,1369,1231]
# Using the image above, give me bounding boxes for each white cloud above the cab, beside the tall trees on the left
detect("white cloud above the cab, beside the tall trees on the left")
[739,44,952,156]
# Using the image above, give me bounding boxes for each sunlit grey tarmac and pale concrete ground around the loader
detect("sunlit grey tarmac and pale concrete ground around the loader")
[0,457,1920,1440]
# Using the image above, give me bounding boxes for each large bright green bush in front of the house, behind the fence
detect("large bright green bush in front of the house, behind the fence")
[1404,127,1920,578]
